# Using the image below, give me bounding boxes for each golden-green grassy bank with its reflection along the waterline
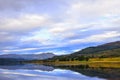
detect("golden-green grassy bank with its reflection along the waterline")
[26,57,120,68]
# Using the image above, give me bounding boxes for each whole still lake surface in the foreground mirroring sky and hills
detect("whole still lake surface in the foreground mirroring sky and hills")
[0,64,120,80]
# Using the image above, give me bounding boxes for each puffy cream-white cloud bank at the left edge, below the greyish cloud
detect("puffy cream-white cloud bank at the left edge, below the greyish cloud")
[0,14,48,32]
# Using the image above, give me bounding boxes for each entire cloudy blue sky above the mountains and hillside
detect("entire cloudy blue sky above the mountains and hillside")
[0,0,120,55]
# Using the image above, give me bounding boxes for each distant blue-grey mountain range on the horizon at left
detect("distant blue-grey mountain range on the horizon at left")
[0,53,55,60]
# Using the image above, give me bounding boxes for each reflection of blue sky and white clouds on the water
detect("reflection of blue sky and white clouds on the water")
[0,69,103,80]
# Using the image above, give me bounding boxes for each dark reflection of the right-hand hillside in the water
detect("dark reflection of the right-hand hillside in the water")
[55,65,120,80]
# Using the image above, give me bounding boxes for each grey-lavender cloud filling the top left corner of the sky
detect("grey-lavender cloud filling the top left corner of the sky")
[0,0,47,11]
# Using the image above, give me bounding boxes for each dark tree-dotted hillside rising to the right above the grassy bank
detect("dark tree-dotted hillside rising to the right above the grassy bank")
[46,41,120,61]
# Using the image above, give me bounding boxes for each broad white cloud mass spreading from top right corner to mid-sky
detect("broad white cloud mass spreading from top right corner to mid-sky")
[48,0,120,42]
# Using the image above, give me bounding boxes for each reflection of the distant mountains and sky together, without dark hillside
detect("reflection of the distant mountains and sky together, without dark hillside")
[0,64,104,80]
